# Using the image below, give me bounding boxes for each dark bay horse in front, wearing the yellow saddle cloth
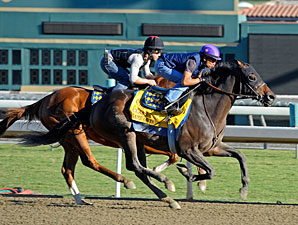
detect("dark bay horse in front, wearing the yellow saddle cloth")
[22,60,275,209]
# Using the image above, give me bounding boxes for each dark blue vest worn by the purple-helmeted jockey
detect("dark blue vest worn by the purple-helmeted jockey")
[161,52,201,74]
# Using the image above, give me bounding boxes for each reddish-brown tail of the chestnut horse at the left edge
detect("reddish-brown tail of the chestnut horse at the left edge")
[0,100,42,136]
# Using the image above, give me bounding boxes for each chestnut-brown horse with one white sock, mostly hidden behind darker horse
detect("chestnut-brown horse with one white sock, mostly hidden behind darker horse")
[0,76,178,204]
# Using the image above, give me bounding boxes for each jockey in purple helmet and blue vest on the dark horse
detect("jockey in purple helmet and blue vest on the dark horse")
[155,44,221,114]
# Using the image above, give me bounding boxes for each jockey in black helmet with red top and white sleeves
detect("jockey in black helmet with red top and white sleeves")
[100,36,164,91]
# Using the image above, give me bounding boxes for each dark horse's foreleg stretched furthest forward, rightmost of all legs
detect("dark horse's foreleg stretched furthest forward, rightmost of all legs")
[208,142,249,200]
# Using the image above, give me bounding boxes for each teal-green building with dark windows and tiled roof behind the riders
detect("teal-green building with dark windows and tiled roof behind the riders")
[0,0,298,95]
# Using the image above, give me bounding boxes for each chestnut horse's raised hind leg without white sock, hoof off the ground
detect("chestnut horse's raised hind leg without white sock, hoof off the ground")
[74,125,136,189]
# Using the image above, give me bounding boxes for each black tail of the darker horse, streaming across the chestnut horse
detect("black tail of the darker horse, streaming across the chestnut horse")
[21,106,92,146]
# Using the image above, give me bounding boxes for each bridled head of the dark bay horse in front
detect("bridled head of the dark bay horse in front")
[235,59,276,106]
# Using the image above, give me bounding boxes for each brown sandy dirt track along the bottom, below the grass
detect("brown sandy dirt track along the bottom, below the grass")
[0,196,298,225]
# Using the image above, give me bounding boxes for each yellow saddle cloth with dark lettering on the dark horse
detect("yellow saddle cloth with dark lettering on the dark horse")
[129,90,192,129]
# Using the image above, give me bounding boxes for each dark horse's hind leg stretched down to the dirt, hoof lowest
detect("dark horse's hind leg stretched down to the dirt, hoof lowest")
[123,139,181,209]
